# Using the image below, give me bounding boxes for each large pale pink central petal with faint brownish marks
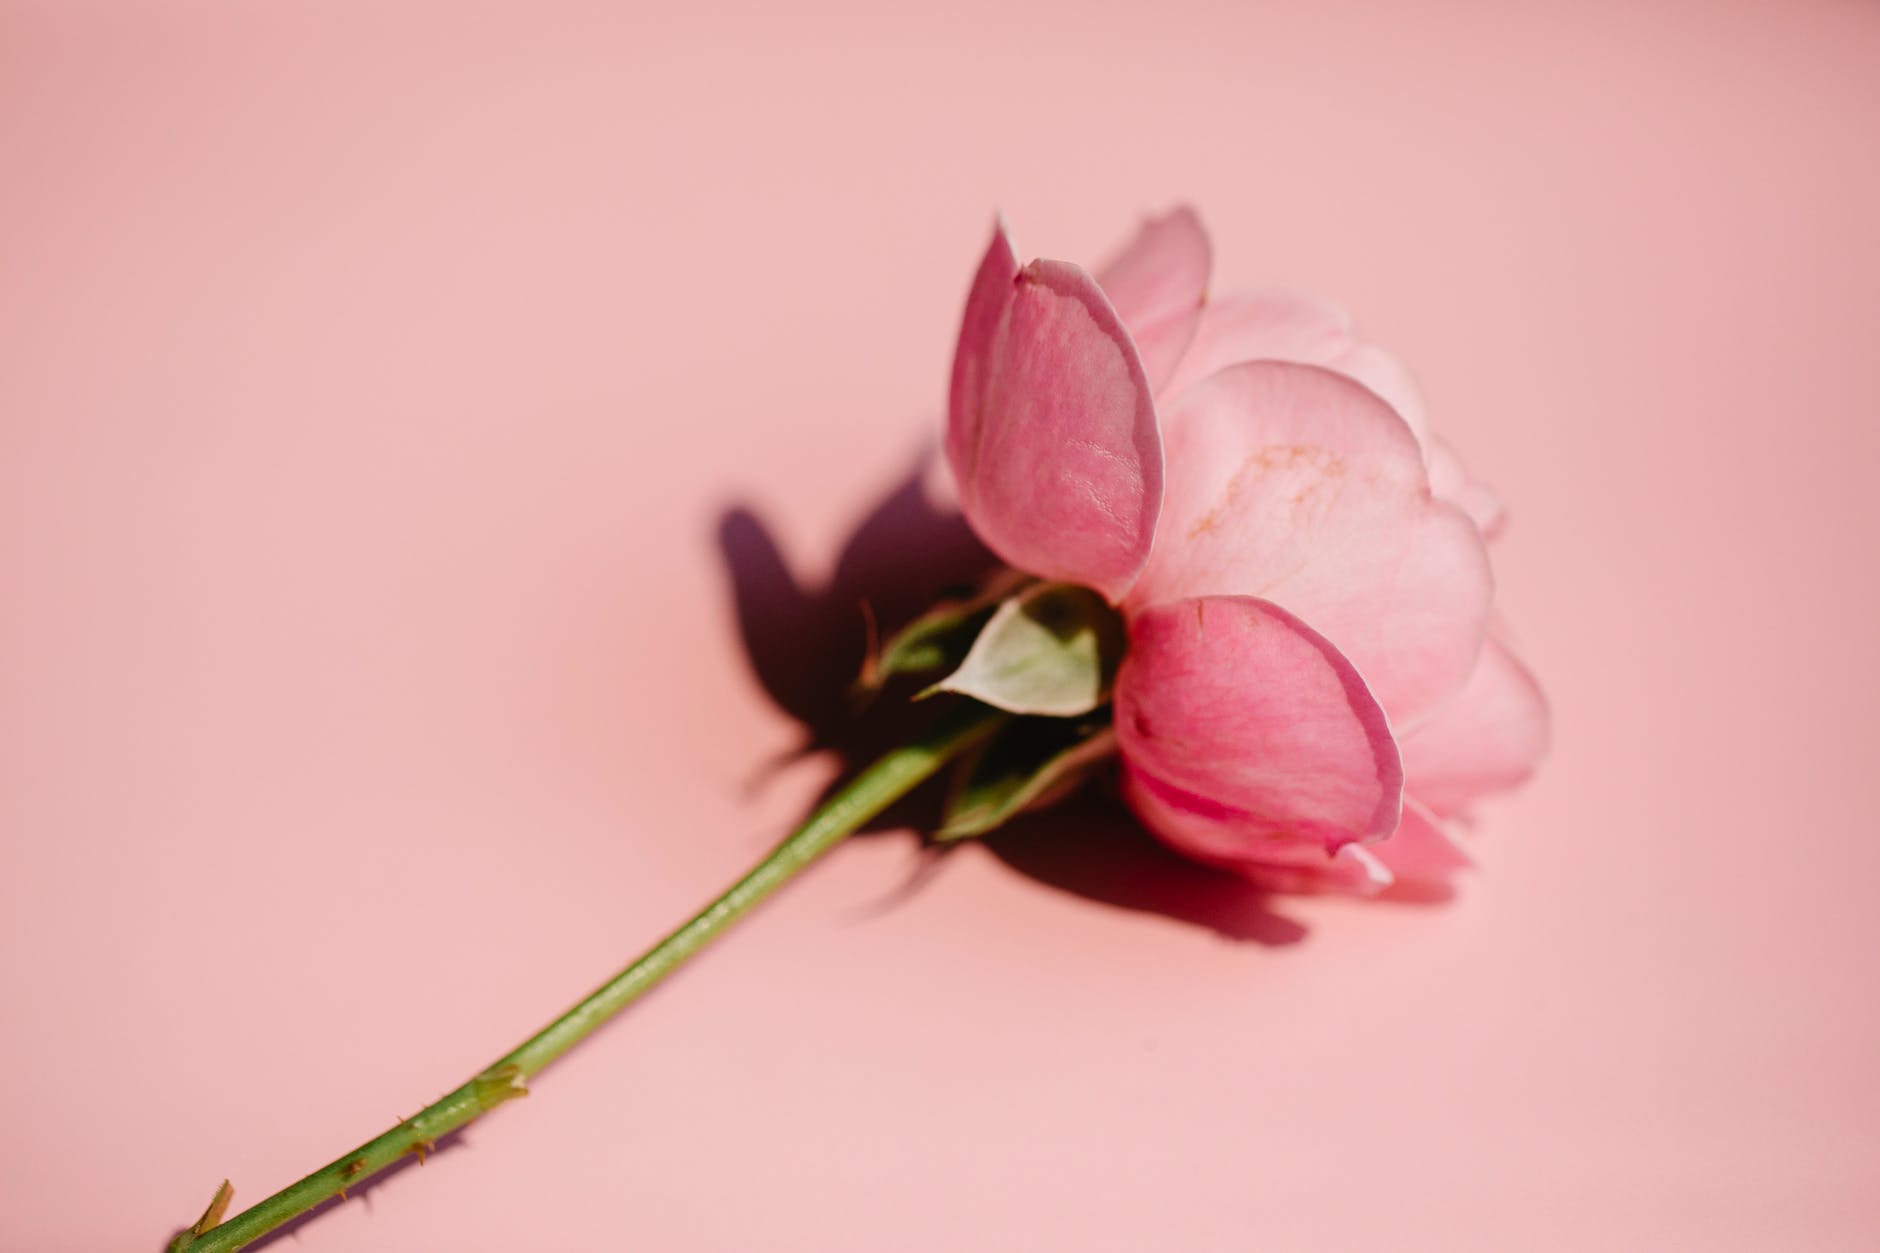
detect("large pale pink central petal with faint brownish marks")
[1130,361,1493,728]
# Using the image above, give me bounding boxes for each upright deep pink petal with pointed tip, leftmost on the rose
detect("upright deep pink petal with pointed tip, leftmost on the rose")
[948,257,1162,600]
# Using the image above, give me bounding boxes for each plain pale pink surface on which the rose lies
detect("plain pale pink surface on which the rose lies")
[0,0,1880,1253]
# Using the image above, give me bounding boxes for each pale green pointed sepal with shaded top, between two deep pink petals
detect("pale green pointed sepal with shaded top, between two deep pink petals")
[923,583,1126,719]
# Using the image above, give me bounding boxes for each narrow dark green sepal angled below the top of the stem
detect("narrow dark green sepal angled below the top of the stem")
[934,707,1117,843]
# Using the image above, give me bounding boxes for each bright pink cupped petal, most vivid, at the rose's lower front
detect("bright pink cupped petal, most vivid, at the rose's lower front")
[1115,596,1402,869]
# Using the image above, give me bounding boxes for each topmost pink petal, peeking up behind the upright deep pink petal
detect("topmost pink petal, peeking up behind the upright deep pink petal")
[1096,205,1214,389]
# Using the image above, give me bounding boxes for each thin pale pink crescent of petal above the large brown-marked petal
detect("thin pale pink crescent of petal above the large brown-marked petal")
[1160,292,1429,448]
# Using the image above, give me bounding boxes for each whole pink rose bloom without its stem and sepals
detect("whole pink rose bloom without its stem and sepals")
[946,209,1547,894]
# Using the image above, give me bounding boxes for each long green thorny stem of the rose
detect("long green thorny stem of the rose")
[169,702,1006,1253]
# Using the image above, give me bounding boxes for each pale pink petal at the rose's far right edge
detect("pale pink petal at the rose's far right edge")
[1402,636,1547,815]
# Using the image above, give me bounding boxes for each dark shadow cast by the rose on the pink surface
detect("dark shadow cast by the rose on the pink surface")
[718,459,1307,946]
